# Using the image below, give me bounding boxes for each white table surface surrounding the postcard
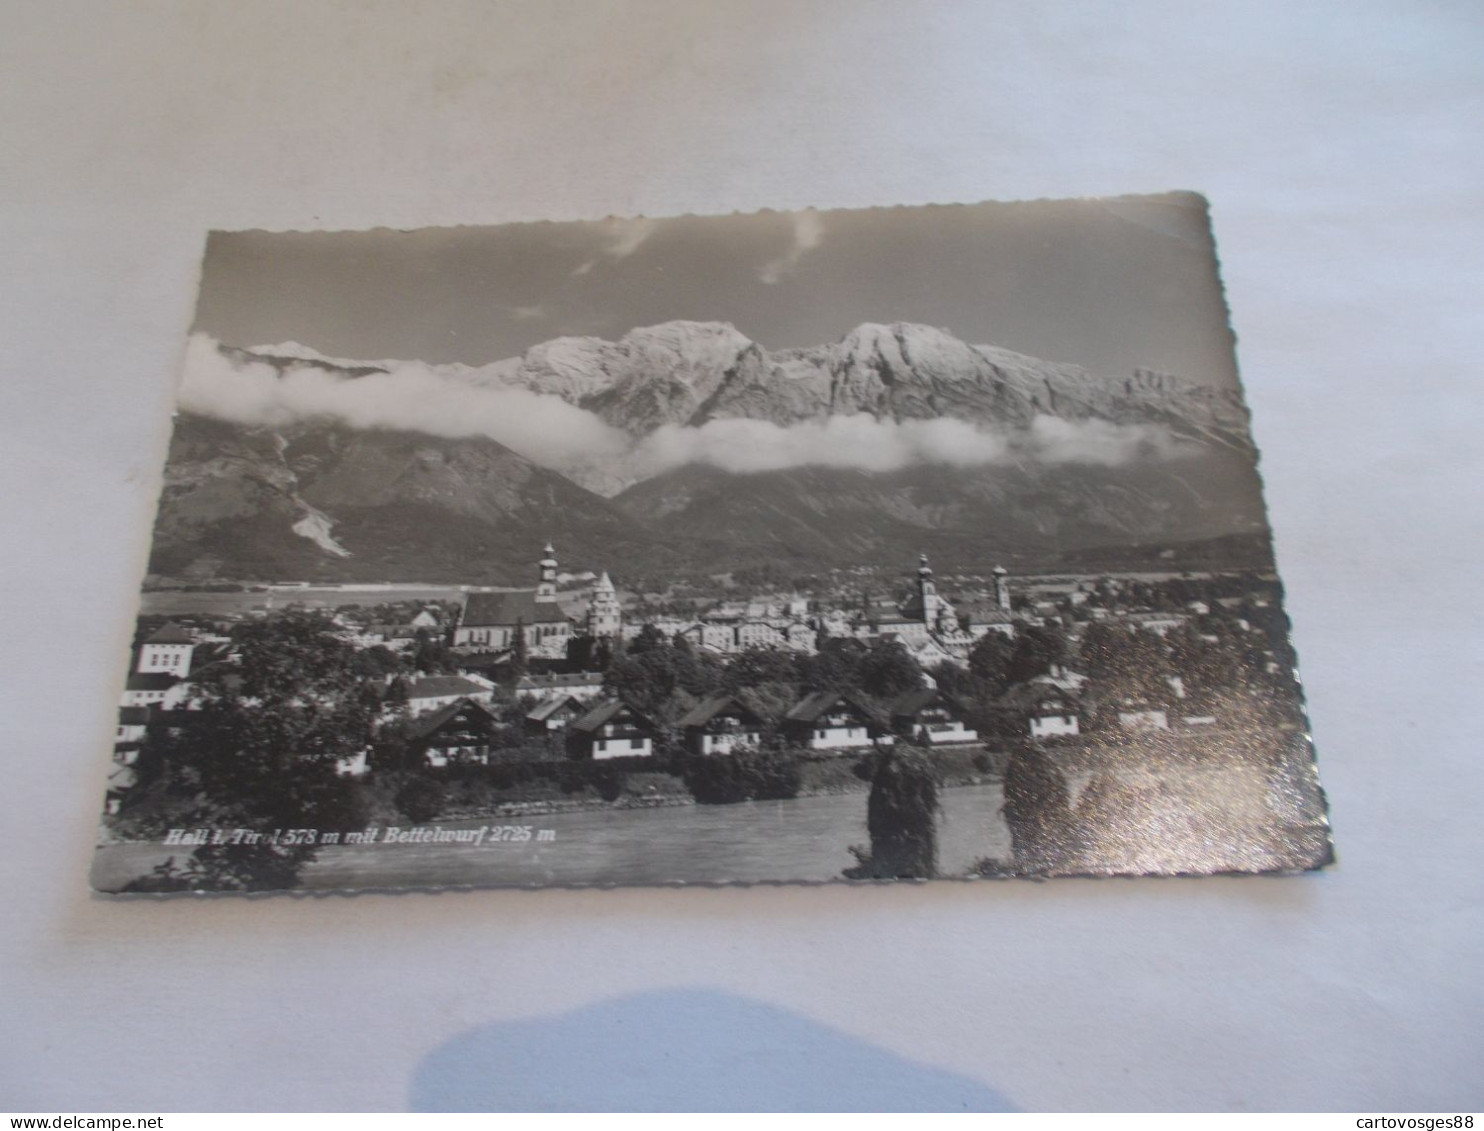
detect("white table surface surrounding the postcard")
[0,0,1484,1113]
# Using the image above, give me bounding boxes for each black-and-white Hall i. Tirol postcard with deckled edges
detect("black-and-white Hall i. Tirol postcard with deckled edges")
[92,193,1331,892]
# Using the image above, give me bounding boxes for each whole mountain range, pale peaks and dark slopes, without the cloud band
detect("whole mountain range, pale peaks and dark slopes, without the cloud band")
[151,322,1264,585]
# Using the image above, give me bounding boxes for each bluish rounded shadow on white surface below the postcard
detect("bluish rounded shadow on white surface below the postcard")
[410,990,1015,1112]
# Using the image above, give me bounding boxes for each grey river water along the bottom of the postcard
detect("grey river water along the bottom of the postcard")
[93,784,1011,891]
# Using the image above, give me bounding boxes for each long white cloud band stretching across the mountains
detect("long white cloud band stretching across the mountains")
[180,334,1177,493]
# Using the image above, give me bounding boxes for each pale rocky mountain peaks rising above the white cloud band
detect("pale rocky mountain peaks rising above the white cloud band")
[224,319,1250,457]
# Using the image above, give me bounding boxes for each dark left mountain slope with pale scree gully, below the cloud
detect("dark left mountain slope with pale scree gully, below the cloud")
[150,414,649,585]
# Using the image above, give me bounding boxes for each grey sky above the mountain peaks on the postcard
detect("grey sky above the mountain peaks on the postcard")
[194,196,1236,386]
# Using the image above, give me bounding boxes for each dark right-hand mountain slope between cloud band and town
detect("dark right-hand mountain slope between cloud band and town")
[614,448,1266,568]
